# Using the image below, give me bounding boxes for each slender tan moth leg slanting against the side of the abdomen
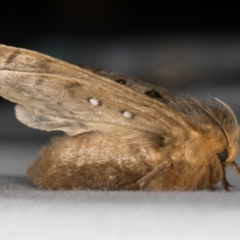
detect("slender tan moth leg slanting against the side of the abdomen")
[130,160,171,189]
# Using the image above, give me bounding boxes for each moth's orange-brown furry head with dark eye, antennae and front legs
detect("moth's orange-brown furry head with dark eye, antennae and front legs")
[192,96,240,190]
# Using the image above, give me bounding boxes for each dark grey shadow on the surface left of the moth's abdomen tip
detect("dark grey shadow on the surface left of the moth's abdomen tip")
[0,174,36,190]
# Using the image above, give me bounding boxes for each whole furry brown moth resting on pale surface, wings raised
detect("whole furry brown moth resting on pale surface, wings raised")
[0,45,240,191]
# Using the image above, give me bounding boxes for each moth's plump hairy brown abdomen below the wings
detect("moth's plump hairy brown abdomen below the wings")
[27,133,153,190]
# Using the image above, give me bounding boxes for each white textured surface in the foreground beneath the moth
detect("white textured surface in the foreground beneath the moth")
[0,191,240,240]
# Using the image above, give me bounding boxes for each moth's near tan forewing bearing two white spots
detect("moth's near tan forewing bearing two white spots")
[0,50,191,138]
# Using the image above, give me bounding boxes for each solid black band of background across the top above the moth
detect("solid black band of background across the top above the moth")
[0,0,239,46]
